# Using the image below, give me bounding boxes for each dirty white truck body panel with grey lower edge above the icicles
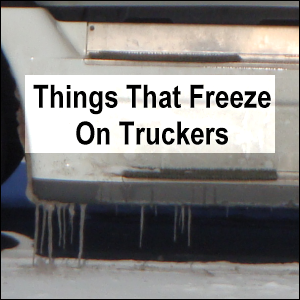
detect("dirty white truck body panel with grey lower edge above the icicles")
[1,8,299,206]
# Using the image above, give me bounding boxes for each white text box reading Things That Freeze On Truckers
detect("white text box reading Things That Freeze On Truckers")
[25,75,275,153]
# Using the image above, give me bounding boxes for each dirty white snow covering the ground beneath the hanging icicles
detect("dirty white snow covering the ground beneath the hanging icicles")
[1,235,299,299]
